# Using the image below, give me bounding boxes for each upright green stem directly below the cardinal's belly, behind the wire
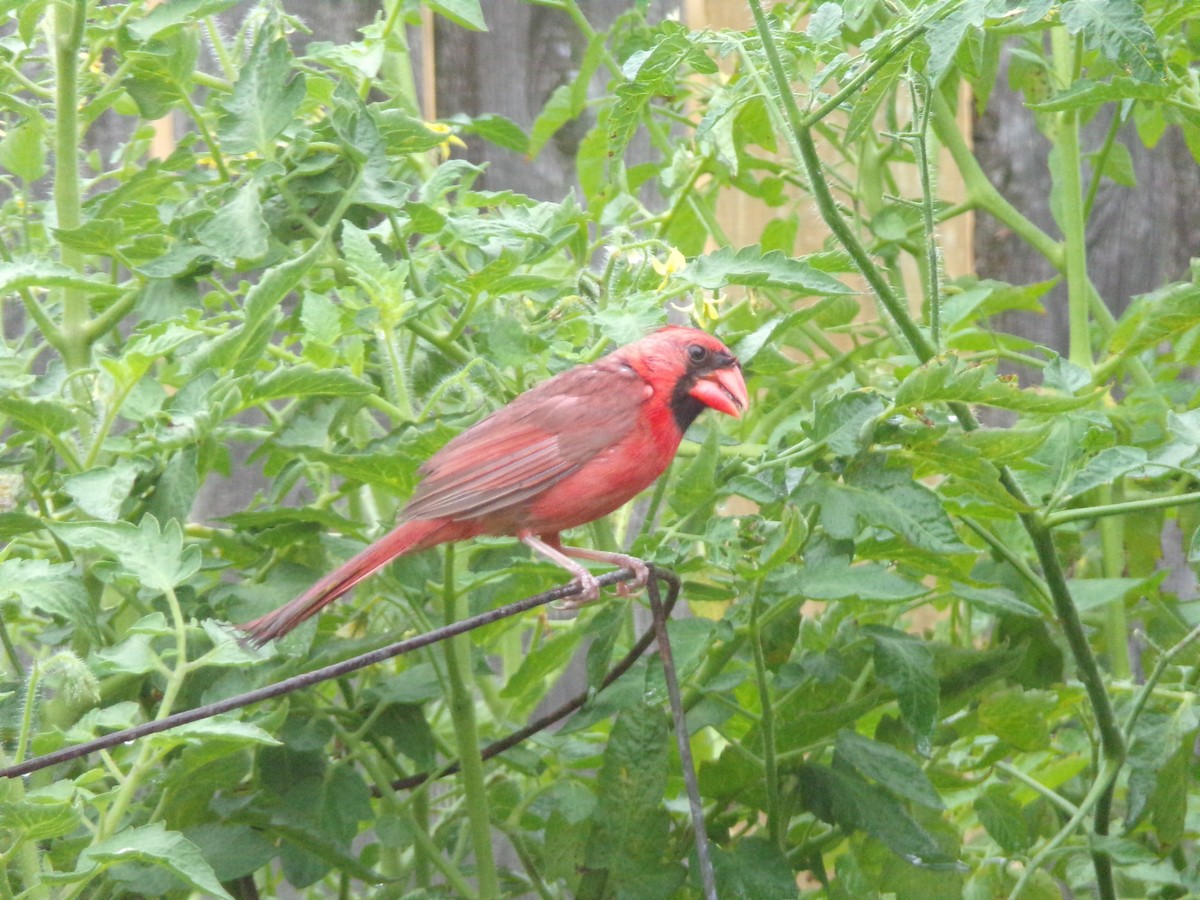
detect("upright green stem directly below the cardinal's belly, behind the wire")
[443,546,500,900]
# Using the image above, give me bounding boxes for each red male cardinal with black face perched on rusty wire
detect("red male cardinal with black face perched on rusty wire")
[241,326,749,646]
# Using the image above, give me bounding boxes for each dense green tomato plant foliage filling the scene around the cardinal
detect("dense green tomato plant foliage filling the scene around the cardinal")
[7,0,1200,898]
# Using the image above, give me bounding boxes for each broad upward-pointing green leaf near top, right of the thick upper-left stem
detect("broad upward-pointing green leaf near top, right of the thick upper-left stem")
[218,29,305,157]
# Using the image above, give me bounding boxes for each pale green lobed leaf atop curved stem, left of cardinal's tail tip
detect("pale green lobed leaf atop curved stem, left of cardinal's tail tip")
[50,515,200,592]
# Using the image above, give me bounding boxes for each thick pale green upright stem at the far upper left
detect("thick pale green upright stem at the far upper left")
[54,0,90,372]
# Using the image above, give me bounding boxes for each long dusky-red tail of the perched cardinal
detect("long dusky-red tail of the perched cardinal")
[239,518,453,647]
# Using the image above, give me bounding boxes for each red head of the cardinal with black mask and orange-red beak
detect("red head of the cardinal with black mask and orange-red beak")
[629,325,750,431]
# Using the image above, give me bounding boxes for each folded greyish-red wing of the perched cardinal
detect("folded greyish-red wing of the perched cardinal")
[403,359,649,520]
